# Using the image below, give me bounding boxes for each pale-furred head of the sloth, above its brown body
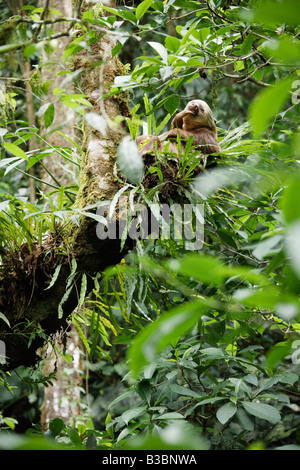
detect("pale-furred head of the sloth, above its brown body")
[182,100,216,132]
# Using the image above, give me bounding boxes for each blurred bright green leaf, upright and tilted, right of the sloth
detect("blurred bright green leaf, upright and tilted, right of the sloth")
[249,78,292,138]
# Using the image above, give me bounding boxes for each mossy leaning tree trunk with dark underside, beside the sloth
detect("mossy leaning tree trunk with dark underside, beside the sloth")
[0,0,129,369]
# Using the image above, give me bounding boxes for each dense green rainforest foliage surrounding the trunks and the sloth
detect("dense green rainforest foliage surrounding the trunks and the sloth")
[0,0,300,450]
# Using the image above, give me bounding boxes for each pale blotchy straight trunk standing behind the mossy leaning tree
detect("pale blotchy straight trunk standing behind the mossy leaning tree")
[40,0,83,431]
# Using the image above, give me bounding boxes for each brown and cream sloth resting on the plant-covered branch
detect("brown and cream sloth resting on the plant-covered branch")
[136,100,221,156]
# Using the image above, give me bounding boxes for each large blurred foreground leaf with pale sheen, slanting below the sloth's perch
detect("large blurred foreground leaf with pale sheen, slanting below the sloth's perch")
[128,300,211,375]
